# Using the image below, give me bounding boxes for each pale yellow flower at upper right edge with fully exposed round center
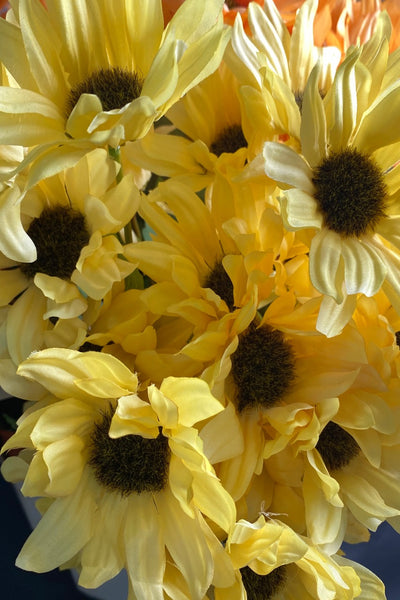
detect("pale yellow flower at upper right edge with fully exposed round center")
[263,30,400,335]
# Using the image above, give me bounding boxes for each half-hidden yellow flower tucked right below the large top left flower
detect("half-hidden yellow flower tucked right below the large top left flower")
[125,62,265,190]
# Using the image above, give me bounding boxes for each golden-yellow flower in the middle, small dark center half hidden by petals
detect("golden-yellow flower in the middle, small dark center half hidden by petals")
[89,179,305,390]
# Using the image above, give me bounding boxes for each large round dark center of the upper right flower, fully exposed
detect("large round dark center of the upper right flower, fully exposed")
[312,148,387,237]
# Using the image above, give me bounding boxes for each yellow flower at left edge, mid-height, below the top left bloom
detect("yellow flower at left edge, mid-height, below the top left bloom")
[0,148,139,397]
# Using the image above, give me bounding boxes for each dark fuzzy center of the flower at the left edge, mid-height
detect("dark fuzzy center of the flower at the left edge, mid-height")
[20,206,90,279]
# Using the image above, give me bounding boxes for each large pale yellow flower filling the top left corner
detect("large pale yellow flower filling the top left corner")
[0,0,229,183]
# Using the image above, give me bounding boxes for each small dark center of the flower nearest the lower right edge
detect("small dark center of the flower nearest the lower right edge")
[316,421,360,471]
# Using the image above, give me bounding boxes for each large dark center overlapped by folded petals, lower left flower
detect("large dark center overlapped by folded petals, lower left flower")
[89,409,171,496]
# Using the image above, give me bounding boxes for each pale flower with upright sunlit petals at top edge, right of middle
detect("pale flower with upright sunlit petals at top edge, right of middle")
[226,0,340,140]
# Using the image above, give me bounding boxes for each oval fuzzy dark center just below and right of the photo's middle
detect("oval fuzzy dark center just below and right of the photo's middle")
[231,325,295,412]
